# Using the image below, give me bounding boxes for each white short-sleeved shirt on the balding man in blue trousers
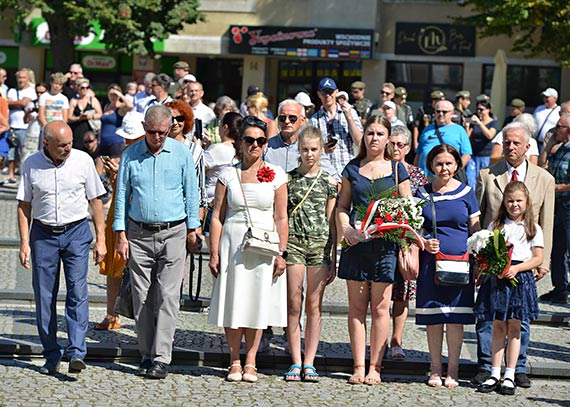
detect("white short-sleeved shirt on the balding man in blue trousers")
[16,149,105,226]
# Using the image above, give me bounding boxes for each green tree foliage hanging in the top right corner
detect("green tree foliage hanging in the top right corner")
[447,0,570,66]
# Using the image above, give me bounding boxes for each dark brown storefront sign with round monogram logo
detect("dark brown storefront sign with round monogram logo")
[396,23,475,57]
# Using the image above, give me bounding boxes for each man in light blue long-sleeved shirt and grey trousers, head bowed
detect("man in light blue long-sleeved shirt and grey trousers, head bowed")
[113,105,201,379]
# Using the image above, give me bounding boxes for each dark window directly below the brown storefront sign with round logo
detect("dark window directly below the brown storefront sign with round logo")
[386,62,463,102]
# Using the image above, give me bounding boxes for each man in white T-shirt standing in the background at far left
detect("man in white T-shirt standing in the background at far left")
[8,68,37,184]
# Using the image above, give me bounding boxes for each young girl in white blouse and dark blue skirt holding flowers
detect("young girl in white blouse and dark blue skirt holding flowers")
[474,181,544,395]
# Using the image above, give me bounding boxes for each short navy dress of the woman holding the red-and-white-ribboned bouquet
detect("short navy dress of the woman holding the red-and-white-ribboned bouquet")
[338,159,409,284]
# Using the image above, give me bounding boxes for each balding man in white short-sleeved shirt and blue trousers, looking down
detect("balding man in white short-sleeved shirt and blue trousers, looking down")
[16,120,107,375]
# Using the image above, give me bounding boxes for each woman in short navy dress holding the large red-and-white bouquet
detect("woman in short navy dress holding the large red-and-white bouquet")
[337,116,411,384]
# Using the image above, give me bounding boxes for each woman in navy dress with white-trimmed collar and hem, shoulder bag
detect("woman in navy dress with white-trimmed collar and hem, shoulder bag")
[416,144,480,388]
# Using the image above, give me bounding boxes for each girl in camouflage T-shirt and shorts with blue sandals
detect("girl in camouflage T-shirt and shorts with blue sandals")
[285,127,338,382]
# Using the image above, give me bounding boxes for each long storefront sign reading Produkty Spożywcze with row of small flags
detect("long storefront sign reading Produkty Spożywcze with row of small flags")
[229,25,374,59]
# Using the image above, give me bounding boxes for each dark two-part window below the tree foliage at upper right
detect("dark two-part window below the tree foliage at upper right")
[482,65,560,106]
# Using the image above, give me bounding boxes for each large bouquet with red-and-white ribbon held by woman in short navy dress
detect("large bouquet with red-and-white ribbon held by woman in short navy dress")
[341,183,425,250]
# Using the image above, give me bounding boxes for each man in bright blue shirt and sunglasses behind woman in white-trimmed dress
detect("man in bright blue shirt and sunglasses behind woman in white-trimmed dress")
[414,100,472,176]
